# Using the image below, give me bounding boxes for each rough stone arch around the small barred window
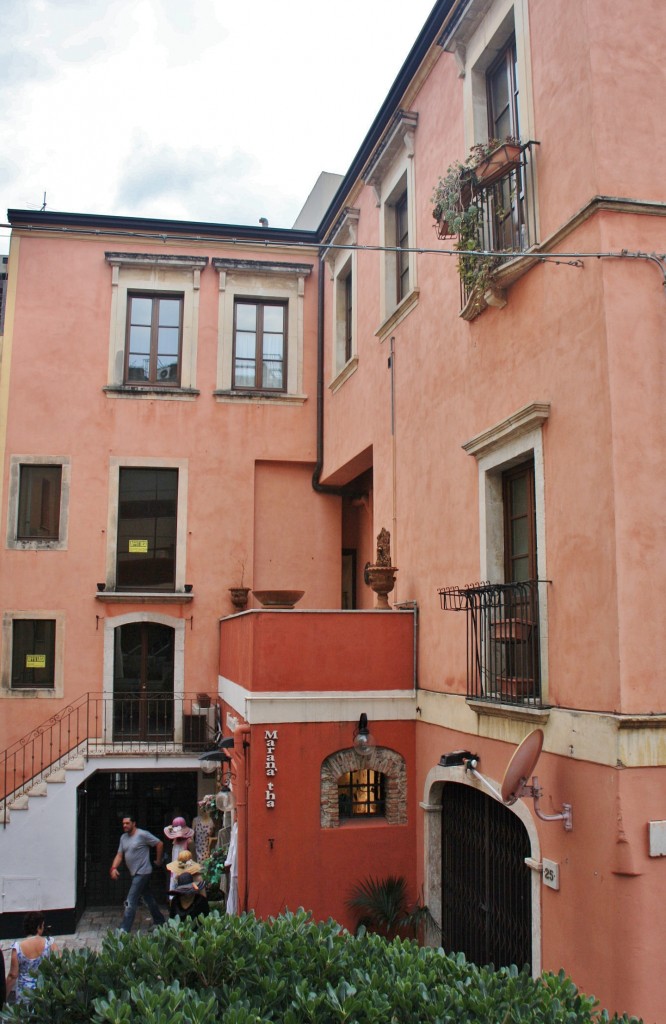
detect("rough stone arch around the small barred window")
[320,746,407,828]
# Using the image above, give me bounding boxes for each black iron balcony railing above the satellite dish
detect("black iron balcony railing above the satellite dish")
[439,580,542,707]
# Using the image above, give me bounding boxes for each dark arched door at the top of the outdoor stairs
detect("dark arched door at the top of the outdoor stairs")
[114,622,174,740]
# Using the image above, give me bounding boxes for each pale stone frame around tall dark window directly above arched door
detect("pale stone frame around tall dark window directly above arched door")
[99,456,189,593]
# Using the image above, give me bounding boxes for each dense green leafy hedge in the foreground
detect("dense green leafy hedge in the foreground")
[0,910,635,1024]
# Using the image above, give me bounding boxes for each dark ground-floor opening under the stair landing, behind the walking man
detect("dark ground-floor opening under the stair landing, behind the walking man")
[77,769,197,913]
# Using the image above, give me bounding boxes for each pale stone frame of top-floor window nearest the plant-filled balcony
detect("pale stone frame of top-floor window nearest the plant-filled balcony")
[363,111,419,341]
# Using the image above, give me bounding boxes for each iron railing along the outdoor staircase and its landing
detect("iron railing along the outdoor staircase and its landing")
[0,692,221,824]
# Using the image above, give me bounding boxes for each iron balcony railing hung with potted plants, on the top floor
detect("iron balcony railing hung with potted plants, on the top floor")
[460,141,539,308]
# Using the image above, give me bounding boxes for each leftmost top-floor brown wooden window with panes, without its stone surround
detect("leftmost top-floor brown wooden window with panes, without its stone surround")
[125,294,182,387]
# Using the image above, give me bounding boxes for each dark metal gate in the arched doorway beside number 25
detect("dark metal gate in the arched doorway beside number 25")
[442,782,532,967]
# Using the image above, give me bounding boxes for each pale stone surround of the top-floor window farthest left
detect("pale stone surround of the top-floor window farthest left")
[105,253,208,401]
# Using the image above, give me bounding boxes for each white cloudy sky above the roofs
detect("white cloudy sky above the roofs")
[0,0,434,253]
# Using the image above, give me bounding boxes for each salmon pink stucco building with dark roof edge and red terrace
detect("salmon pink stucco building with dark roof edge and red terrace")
[0,0,666,1022]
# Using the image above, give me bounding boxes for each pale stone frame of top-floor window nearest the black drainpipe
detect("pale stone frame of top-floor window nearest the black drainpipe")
[213,258,313,404]
